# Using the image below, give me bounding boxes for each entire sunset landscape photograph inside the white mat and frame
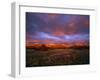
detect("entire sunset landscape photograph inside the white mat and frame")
[26,12,90,67]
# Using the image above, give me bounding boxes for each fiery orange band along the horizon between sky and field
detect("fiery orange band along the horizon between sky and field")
[26,43,89,50]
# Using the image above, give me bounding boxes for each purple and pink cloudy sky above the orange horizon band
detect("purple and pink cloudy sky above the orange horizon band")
[26,12,89,45]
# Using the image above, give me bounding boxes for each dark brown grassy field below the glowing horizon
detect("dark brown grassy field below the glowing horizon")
[26,48,89,67]
